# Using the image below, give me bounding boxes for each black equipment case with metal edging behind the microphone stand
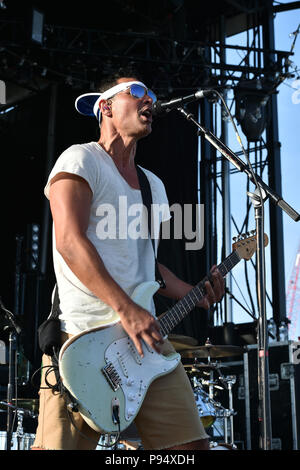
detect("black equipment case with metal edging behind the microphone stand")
[220,341,300,450]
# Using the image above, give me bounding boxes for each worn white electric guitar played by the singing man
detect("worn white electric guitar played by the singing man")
[59,235,268,433]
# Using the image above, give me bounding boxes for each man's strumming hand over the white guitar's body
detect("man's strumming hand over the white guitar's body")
[119,302,164,357]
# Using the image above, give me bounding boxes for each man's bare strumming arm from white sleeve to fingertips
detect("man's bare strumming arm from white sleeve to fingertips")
[50,173,162,354]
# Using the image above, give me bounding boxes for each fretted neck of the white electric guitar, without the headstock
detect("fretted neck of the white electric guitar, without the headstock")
[159,251,241,336]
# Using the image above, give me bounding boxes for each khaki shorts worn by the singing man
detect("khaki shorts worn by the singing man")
[32,334,208,450]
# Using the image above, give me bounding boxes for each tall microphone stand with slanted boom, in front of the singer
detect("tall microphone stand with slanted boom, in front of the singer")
[177,107,300,450]
